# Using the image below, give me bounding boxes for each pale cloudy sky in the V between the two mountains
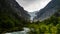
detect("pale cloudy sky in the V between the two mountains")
[16,0,51,12]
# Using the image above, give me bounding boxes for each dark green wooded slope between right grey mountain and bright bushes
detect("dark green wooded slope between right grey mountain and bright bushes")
[42,9,60,26]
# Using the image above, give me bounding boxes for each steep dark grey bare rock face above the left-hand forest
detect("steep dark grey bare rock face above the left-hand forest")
[0,0,30,19]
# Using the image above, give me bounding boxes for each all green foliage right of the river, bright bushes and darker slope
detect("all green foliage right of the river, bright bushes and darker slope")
[28,10,60,34]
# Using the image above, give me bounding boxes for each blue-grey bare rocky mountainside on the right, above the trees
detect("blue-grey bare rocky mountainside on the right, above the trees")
[34,0,60,20]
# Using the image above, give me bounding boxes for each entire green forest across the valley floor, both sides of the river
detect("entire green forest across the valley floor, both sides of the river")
[0,10,60,34]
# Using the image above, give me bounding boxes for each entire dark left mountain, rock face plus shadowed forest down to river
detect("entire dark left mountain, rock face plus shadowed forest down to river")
[0,0,30,33]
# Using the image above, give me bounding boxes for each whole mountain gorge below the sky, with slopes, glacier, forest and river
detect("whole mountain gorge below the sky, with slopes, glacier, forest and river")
[0,0,60,34]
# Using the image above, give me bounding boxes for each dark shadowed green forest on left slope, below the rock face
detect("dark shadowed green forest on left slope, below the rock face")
[0,10,25,33]
